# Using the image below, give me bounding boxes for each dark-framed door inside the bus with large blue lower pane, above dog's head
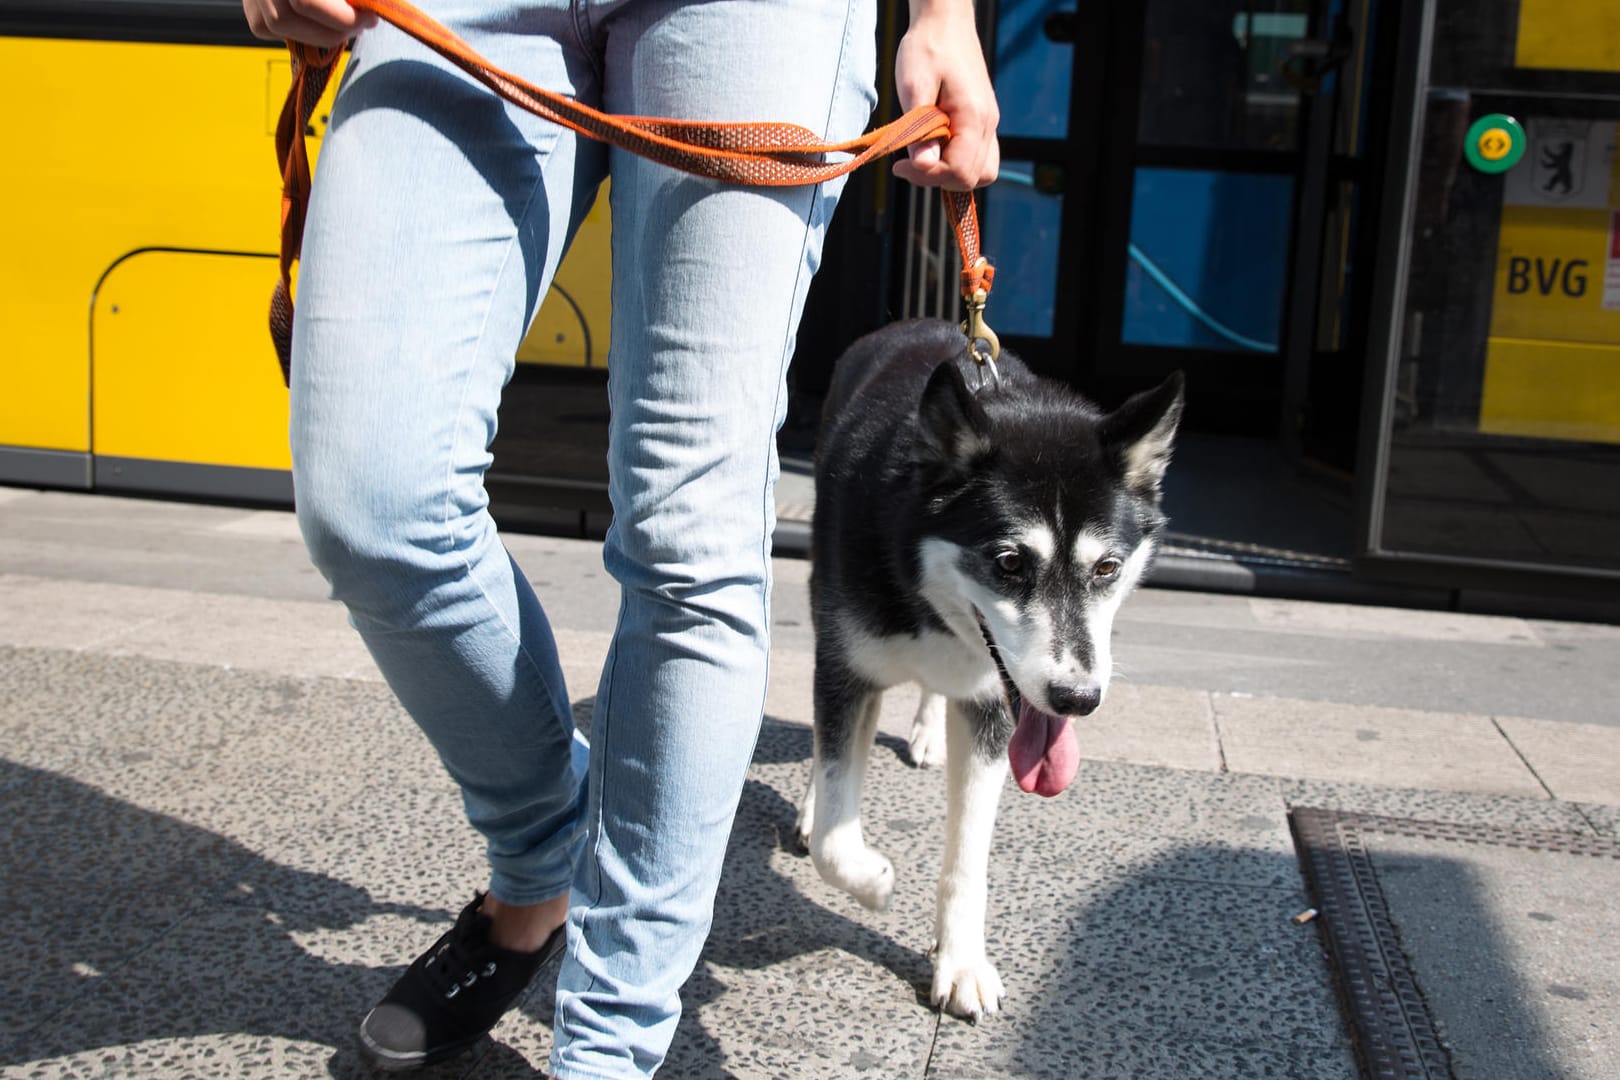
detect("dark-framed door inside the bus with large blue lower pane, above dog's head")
[1094,0,1354,440]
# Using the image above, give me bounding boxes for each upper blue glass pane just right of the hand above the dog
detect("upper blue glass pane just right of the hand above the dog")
[996,0,1074,139]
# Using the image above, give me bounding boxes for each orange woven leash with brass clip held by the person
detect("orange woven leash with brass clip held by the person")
[271,0,1000,381]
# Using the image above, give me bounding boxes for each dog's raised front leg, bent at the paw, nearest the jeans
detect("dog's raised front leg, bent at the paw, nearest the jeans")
[799,657,894,912]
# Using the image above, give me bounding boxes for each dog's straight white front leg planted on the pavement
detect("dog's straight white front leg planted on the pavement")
[933,701,1011,1020]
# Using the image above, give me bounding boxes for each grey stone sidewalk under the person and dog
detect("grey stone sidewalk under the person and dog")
[0,489,1620,1078]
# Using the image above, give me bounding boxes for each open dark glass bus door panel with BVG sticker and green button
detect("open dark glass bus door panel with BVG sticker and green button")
[1361,0,1620,596]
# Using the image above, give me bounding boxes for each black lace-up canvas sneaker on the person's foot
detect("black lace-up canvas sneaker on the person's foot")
[360,892,564,1072]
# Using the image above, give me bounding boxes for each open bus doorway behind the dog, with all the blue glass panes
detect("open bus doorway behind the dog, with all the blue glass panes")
[933,0,1375,468]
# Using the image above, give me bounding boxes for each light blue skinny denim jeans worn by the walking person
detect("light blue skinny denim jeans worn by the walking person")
[292,0,875,1080]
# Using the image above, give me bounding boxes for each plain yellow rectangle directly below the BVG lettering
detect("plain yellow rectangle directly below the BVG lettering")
[1479,337,1620,444]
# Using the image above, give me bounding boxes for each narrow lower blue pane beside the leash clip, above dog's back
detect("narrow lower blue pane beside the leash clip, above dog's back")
[983,162,1063,337]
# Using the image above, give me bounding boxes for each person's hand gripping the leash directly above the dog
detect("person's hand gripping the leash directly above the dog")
[894,0,1001,191]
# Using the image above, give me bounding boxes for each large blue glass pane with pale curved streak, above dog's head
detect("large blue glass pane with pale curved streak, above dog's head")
[1119,168,1294,353]
